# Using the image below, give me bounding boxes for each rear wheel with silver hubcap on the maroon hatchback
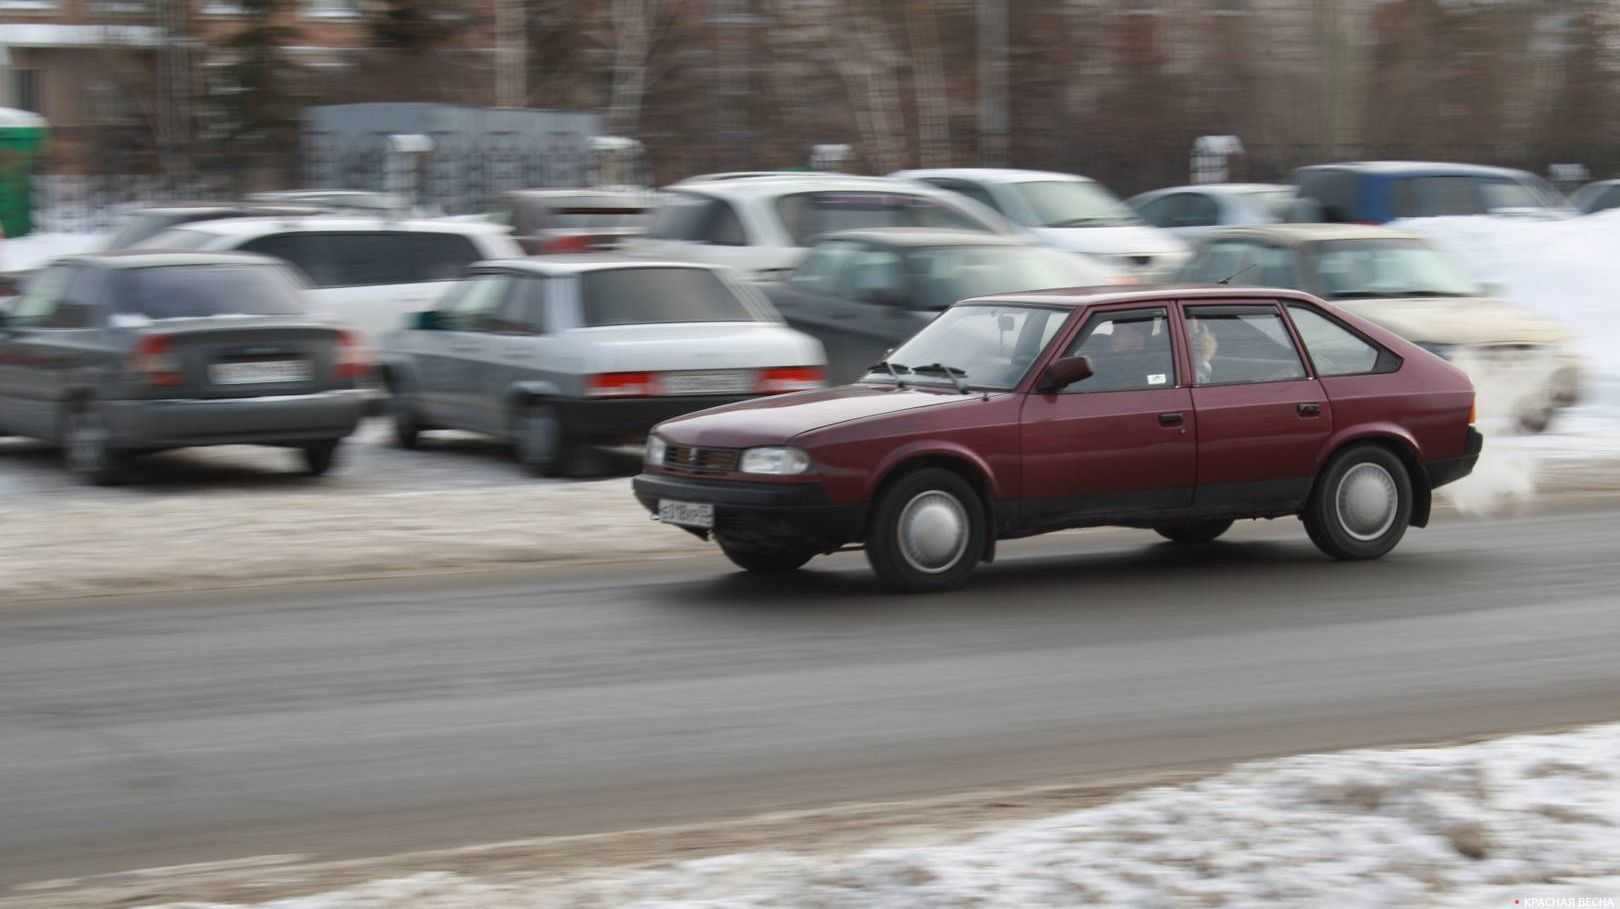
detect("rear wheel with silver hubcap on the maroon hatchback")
[1301,444,1413,561]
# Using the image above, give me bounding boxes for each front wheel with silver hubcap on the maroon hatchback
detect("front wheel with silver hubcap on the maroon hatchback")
[867,467,990,591]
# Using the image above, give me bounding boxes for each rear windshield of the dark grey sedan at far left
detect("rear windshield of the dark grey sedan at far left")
[115,266,303,319]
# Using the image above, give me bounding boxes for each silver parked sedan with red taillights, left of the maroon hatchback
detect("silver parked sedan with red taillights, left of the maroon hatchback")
[382,256,826,476]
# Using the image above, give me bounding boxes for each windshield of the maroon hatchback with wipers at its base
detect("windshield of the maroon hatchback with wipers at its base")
[862,303,1069,390]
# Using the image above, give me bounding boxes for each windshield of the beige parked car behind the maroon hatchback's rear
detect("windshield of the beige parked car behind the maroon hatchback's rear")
[1314,240,1479,300]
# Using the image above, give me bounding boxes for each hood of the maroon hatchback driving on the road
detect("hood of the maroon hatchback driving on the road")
[658,384,978,447]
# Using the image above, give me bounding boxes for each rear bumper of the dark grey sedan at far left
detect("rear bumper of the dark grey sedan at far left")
[104,389,366,449]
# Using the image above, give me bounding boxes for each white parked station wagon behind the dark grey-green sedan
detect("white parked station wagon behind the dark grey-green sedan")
[625,173,1019,280]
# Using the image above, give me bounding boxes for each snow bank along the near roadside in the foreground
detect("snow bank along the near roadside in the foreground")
[145,724,1620,909]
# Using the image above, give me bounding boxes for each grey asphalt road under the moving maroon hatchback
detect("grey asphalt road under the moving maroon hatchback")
[0,510,1620,885]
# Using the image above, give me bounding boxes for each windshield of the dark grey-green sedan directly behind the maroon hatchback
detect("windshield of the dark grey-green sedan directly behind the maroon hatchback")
[910,246,1115,309]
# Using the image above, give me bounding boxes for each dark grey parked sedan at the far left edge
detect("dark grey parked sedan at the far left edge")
[0,253,371,484]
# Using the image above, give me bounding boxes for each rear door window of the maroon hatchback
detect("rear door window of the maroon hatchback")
[1187,306,1306,386]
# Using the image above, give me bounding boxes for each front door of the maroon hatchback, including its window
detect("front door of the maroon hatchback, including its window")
[1021,305,1202,528]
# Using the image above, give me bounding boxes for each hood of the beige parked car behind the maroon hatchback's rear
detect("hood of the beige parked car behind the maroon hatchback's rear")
[1333,297,1570,345]
